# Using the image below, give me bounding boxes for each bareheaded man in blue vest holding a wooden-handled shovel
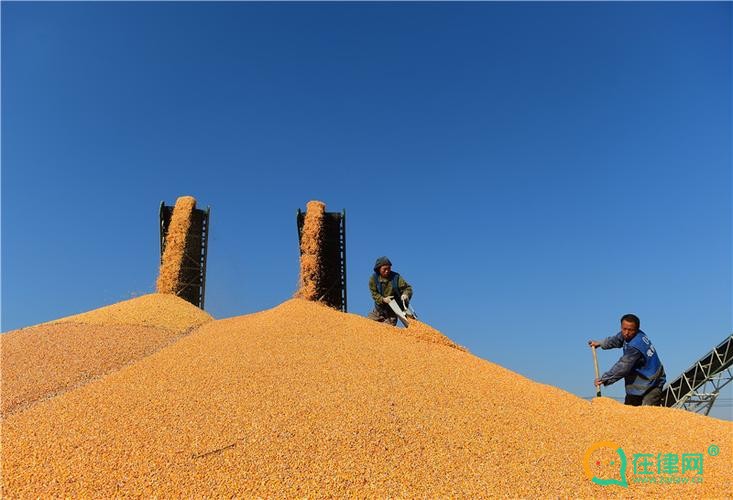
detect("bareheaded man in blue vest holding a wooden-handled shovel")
[588,314,667,406]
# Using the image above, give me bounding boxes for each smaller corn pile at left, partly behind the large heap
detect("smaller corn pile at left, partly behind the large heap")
[0,294,212,416]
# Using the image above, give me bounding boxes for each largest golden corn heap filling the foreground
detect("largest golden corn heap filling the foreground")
[2,299,733,498]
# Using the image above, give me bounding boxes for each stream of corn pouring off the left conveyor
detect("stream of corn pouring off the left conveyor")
[157,196,196,295]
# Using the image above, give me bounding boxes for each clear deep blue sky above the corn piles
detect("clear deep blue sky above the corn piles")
[2,2,733,418]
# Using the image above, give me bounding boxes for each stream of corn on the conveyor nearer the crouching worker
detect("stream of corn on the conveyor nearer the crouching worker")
[296,201,326,300]
